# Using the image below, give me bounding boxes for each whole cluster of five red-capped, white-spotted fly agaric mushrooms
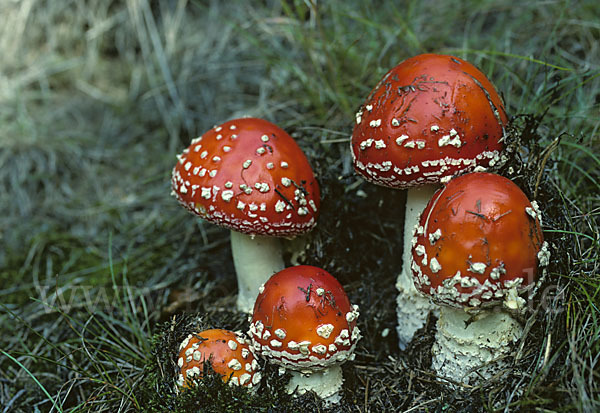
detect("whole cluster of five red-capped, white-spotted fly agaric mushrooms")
[166,50,549,403]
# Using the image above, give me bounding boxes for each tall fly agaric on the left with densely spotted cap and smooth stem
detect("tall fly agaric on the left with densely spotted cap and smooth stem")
[171,118,320,312]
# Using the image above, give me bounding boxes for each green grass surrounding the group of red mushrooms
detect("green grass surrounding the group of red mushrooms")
[0,0,600,412]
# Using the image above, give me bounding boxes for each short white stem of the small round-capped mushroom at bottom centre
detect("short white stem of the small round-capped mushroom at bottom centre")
[287,365,344,404]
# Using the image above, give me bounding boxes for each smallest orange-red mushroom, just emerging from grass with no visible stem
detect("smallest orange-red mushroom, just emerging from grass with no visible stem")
[177,329,261,389]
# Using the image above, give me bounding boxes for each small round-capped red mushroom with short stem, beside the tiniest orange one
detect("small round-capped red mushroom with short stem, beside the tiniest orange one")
[248,265,361,403]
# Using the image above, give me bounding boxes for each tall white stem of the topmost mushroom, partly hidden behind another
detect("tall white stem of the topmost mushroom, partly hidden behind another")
[396,185,438,350]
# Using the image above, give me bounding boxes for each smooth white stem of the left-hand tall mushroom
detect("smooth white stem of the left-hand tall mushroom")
[231,231,285,313]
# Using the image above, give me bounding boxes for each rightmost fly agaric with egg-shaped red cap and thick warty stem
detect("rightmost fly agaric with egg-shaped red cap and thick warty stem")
[411,172,549,384]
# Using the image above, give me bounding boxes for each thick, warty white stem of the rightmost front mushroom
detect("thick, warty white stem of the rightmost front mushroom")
[432,306,523,384]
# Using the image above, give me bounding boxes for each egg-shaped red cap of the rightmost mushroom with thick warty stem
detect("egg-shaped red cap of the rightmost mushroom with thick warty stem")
[411,172,543,308]
